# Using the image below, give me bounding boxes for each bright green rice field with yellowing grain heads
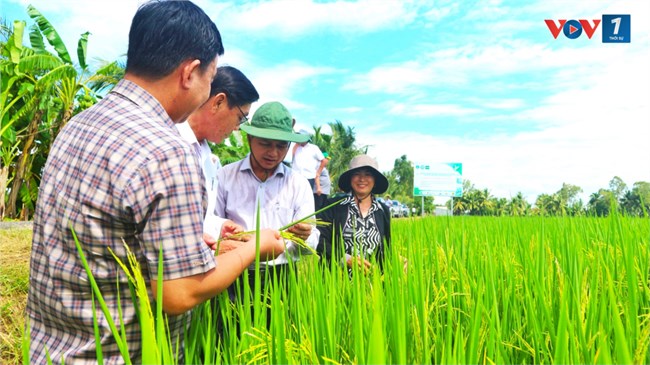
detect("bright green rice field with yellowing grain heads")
[20,215,650,364]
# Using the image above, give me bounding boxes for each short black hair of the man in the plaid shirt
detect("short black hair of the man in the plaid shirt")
[126,0,224,80]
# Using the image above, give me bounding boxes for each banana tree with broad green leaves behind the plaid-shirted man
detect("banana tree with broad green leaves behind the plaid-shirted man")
[6,5,117,217]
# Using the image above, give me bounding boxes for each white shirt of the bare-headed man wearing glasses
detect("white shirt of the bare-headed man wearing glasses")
[176,122,226,238]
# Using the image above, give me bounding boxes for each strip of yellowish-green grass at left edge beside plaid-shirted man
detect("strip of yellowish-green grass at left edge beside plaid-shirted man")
[0,228,32,365]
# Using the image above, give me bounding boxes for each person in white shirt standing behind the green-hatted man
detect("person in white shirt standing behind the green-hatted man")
[291,129,329,206]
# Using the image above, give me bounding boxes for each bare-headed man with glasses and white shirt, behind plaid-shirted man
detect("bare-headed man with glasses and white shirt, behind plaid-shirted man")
[176,66,259,247]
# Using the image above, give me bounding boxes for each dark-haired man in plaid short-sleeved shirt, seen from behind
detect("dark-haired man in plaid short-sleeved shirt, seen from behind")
[25,1,284,364]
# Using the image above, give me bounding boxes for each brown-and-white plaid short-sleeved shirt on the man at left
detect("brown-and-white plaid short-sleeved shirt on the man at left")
[27,80,215,364]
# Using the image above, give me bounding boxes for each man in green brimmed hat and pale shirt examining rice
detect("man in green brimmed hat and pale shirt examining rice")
[216,102,319,298]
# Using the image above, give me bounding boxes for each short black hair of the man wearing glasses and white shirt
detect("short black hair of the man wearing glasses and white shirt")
[210,66,260,107]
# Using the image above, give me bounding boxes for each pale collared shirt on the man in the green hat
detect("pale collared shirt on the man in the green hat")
[216,154,320,265]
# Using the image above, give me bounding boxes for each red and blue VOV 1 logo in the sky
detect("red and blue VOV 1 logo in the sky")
[544,14,631,43]
